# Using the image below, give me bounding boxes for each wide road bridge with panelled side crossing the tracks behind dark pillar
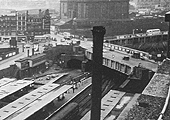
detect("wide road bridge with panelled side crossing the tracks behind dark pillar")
[80,41,158,75]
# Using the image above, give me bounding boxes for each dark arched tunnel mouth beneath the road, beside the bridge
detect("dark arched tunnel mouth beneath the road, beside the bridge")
[67,59,82,69]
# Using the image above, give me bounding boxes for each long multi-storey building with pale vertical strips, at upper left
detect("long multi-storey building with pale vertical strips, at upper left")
[0,9,50,40]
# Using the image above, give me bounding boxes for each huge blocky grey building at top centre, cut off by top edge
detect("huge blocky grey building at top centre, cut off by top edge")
[60,0,129,24]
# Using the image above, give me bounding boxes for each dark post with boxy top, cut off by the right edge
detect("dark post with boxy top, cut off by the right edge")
[165,12,170,59]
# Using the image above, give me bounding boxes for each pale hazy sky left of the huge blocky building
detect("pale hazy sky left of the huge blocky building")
[0,0,60,10]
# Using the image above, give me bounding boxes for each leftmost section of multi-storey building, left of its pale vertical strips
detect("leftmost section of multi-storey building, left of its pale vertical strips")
[0,14,17,40]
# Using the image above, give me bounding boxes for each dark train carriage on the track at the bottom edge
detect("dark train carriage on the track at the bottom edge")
[46,102,79,120]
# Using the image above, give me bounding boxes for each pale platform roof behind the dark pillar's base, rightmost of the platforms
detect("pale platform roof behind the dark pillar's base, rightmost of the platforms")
[81,90,139,120]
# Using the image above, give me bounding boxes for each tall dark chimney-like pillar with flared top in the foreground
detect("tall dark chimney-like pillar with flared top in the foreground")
[91,26,106,120]
